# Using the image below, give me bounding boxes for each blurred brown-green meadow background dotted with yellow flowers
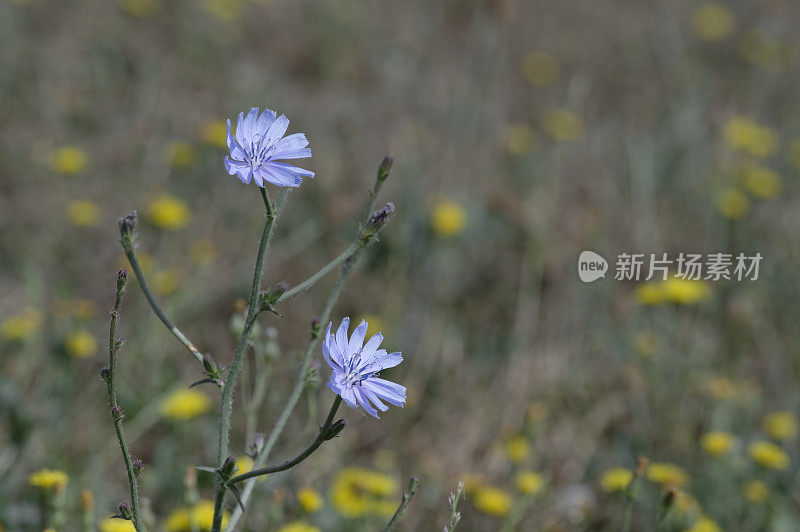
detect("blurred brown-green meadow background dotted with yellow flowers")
[0,0,800,532]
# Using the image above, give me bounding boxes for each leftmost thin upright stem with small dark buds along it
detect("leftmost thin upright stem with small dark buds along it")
[106,270,145,532]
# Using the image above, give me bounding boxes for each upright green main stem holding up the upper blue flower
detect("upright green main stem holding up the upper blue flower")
[212,187,289,532]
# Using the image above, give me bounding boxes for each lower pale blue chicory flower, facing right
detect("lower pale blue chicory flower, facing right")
[322,318,406,417]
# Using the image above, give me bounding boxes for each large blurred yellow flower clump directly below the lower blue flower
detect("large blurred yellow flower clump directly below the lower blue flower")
[331,467,398,518]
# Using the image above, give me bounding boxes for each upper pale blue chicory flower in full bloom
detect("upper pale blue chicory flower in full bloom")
[225,107,314,188]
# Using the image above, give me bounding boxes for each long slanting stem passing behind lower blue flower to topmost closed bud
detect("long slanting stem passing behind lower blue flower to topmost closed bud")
[225,155,394,532]
